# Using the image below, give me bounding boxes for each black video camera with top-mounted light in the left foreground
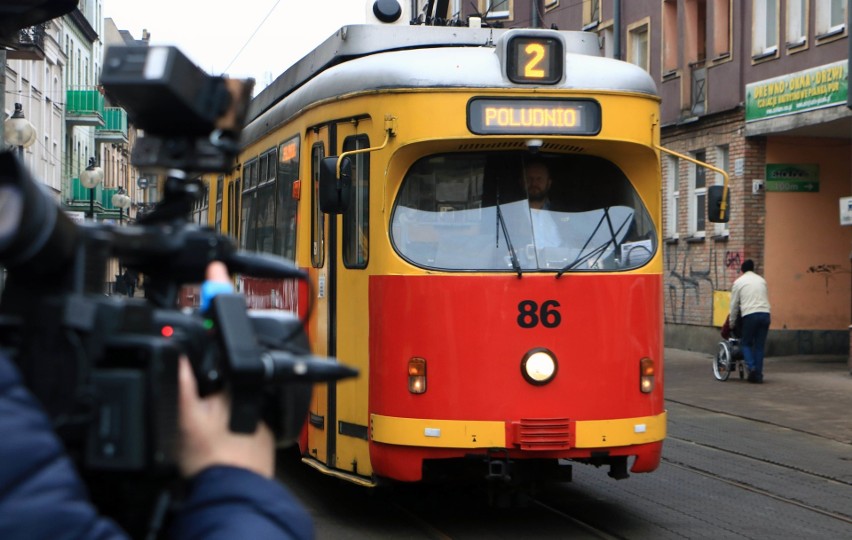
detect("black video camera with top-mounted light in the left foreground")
[0,47,357,536]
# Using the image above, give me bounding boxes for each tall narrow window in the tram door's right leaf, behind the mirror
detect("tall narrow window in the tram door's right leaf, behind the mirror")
[343,135,370,268]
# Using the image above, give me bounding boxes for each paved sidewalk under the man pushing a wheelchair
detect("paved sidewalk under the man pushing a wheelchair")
[665,349,852,444]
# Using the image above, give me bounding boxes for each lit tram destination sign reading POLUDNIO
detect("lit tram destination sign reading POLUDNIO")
[467,98,601,135]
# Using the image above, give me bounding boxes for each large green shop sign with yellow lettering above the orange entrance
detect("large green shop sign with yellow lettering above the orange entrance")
[746,60,849,122]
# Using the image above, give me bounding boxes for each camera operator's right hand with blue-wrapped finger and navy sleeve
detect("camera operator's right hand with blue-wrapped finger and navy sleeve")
[170,262,314,540]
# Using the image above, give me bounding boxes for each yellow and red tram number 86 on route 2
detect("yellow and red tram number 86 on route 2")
[210,17,724,485]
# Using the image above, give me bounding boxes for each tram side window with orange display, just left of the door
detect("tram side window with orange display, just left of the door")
[275,136,299,260]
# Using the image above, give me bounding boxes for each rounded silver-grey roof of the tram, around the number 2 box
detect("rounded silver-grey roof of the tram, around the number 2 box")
[243,25,657,141]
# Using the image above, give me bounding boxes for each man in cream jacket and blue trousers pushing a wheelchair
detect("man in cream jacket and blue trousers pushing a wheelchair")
[730,259,771,383]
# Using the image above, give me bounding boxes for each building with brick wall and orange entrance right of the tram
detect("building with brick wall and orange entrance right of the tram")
[461,0,852,355]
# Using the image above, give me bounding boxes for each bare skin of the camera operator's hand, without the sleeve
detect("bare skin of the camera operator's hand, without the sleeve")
[179,262,275,478]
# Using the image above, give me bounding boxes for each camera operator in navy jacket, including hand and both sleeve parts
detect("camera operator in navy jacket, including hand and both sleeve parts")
[0,263,314,540]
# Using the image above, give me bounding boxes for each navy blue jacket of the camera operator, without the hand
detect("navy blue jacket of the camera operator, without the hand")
[0,353,314,540]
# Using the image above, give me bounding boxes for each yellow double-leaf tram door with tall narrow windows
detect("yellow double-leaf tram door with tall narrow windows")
[306,119,372,476]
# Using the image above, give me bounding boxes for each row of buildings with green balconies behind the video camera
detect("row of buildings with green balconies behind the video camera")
[0,0,146,292]
